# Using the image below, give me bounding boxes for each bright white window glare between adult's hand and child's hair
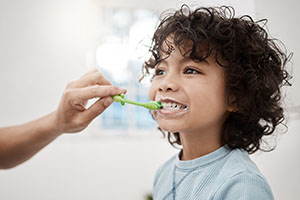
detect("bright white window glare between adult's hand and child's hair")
[96,9,157,83]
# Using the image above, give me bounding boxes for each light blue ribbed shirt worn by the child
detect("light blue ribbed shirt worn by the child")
[153,146,274,200]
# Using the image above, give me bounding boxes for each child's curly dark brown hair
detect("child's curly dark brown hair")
[143,4,292,154]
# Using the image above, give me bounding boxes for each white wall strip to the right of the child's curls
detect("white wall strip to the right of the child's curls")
[253,0,300,200]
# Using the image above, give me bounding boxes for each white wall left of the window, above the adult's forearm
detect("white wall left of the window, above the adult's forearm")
[0,0,100,125]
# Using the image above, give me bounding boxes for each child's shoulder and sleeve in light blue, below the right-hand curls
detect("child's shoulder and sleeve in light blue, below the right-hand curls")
[214,149,274,200]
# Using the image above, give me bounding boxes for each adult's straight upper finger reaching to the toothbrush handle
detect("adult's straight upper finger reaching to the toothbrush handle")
[68,85,126,101]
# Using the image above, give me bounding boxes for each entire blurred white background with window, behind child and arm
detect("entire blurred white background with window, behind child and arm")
[0,0,300,200]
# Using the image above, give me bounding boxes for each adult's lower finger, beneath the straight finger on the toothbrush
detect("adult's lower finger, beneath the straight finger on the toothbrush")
[82,97,113,122]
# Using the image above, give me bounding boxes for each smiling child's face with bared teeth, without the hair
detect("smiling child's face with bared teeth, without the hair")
[149,44,230,134]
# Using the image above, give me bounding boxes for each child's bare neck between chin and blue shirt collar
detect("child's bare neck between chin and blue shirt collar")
[180,130,222,160]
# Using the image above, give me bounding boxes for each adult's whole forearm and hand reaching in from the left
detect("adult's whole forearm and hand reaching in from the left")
[0,69,126,169]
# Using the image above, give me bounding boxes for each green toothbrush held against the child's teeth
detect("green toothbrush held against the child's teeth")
[112,94,162,110]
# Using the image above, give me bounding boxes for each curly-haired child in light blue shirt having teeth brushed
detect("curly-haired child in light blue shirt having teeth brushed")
[144,5,289,200]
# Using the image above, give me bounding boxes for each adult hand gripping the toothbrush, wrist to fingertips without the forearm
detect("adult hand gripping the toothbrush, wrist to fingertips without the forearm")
[54,69,126,134]
